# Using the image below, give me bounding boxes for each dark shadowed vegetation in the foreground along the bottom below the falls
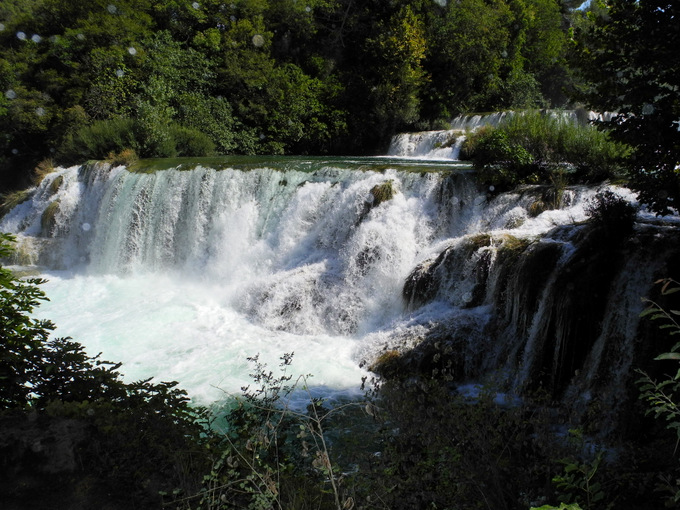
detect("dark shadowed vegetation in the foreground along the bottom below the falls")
[0,232,680,510]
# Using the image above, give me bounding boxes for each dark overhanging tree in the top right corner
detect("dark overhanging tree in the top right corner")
[580,0,680,215]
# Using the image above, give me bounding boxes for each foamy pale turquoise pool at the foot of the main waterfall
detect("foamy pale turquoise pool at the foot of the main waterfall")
[36,272,365,404]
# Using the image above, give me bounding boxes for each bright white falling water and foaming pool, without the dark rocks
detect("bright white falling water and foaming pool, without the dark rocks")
[0,158,640,403]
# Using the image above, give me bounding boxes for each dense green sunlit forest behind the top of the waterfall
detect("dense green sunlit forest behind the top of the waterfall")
[0,0,584,187]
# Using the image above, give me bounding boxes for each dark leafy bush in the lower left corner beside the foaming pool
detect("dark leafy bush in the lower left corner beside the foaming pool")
[0,234,210,509]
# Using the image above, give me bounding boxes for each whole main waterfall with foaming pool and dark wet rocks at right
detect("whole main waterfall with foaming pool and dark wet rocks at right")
[0,158,678,422]
